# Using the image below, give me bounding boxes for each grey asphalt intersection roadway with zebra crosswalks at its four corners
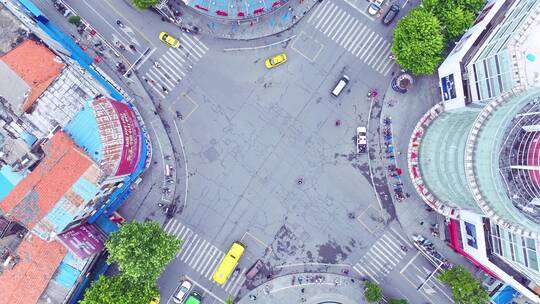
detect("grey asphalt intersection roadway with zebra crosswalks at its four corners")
[34,0,456,303]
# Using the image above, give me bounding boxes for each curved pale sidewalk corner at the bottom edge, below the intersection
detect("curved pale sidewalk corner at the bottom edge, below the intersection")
[236,273,367,304]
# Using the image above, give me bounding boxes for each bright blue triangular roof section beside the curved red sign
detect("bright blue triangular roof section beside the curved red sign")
[64,101,103,163]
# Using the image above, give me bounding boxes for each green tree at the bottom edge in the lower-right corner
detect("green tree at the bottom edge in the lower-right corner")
[438,265,489,304]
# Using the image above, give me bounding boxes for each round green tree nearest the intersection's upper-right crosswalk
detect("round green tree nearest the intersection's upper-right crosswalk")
[392,8,444,75]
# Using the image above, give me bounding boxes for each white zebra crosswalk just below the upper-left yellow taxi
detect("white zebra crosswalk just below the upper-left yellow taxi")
[143,33,208,98]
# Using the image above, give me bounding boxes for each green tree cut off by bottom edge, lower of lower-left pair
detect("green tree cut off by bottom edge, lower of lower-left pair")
[79,274,159,304]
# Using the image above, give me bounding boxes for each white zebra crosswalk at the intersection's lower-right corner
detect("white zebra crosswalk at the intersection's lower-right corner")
[353,228,410,283]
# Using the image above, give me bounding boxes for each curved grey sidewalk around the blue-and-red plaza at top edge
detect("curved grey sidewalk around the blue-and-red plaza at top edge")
[154,0,322,40]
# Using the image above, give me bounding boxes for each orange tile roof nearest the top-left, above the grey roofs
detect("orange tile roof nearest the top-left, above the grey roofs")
[0,40,64,112]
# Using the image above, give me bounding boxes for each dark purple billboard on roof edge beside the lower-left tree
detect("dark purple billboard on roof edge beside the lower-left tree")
[58,224,107,259]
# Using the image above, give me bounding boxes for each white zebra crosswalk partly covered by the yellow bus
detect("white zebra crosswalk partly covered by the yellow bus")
[164,219,246,297]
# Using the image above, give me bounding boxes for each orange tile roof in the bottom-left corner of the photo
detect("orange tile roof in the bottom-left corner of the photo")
[0,235,67,304]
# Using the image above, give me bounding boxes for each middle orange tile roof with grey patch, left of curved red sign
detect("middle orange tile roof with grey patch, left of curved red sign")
[0,131,94,230]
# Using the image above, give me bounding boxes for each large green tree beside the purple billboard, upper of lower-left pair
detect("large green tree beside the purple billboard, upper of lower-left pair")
[105,221,181,284]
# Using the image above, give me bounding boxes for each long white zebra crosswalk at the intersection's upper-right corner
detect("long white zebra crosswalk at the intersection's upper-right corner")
[308,1,394,76]
